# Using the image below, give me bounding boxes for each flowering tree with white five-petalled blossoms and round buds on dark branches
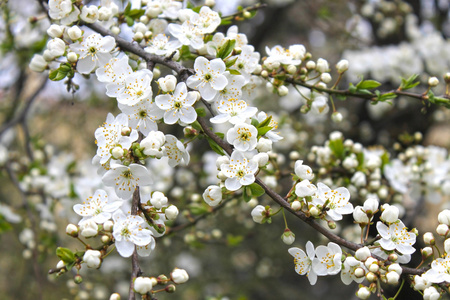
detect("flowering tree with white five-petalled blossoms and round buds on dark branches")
[0,0,450,299]
